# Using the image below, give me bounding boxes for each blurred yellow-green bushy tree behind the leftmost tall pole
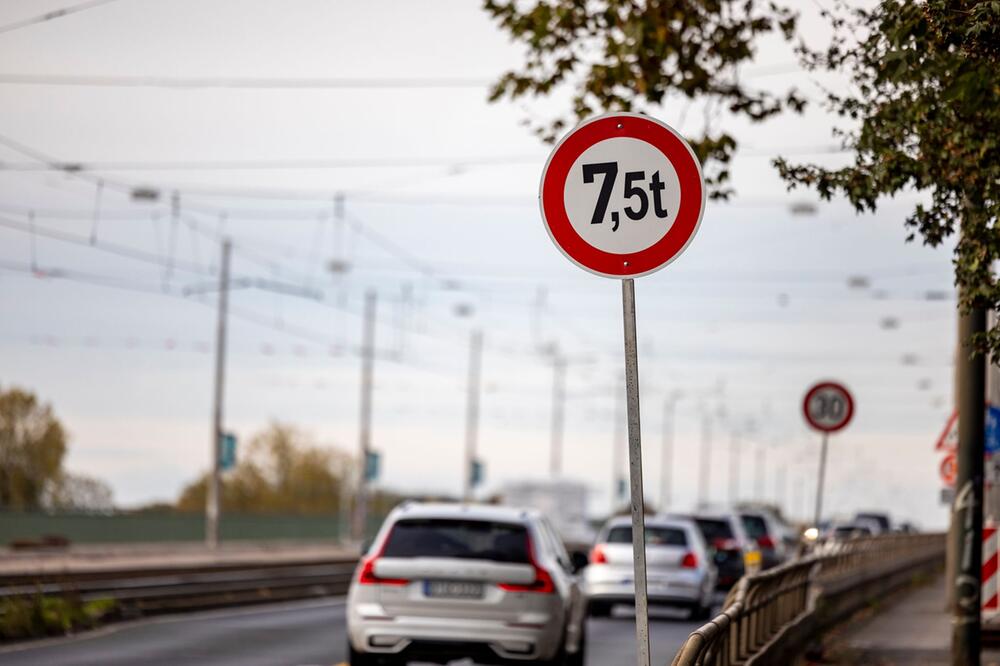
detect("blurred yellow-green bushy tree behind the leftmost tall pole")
[177,423,351,514]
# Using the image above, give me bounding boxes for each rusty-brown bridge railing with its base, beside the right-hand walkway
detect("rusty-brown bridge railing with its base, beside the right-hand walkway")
[673,534,945,666]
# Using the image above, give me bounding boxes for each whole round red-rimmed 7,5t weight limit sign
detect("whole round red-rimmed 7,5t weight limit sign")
[538,113,705,278]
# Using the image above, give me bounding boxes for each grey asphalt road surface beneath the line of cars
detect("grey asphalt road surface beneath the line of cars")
[0,599,701,666]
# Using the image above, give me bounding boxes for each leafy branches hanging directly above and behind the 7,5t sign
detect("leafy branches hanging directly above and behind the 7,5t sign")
[484,0,804,198]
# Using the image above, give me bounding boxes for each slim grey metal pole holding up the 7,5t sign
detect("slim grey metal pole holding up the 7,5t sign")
[622,278,649,666]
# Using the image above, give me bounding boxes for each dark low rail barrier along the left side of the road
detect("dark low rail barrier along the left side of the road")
[0,559,356,615]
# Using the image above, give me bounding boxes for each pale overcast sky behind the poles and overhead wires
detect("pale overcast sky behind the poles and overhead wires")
[0,0,955,527]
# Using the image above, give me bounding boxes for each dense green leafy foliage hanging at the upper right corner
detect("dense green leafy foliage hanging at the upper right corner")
[776,0,1000,362]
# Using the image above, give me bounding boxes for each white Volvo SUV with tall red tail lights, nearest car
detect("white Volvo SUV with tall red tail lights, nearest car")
[347,503,586,666]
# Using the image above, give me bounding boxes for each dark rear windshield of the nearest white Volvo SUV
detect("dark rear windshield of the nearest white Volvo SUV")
[382,518,531,564]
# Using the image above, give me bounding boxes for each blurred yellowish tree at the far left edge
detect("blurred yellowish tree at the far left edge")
[0,388,66,509]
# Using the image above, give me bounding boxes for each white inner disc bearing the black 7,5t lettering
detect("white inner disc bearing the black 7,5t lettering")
[563,137,681,254]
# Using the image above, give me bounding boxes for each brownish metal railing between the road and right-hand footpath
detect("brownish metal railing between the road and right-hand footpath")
[672,534,945,666]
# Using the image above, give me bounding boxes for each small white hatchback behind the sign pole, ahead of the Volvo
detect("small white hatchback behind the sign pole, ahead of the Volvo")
[585,517,718,619]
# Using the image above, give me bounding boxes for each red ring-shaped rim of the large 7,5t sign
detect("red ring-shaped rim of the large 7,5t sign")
[538,113,705,278]
